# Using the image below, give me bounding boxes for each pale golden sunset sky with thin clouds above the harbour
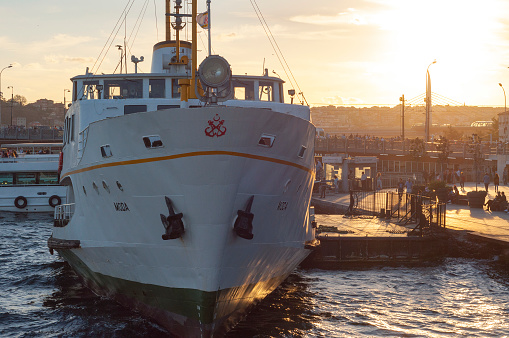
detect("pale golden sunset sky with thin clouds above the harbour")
[0,0,509,106]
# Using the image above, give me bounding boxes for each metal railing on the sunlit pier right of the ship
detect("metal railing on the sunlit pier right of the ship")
[350,191,446,236]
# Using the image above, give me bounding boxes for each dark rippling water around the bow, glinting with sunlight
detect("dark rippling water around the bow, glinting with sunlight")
[0,214,509,338]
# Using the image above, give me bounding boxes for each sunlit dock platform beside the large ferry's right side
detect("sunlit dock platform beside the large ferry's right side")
[305,183,509,268]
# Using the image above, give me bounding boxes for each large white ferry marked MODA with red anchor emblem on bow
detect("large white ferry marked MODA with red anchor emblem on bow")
[48,1,315,337]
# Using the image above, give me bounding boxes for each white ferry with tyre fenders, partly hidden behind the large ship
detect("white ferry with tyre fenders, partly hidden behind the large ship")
[0,143,66,212]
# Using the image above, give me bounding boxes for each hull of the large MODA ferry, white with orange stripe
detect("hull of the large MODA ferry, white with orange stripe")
[53,107,314,337]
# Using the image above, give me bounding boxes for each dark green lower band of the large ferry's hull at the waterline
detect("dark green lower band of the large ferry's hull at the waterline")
[57,249,287,337]
